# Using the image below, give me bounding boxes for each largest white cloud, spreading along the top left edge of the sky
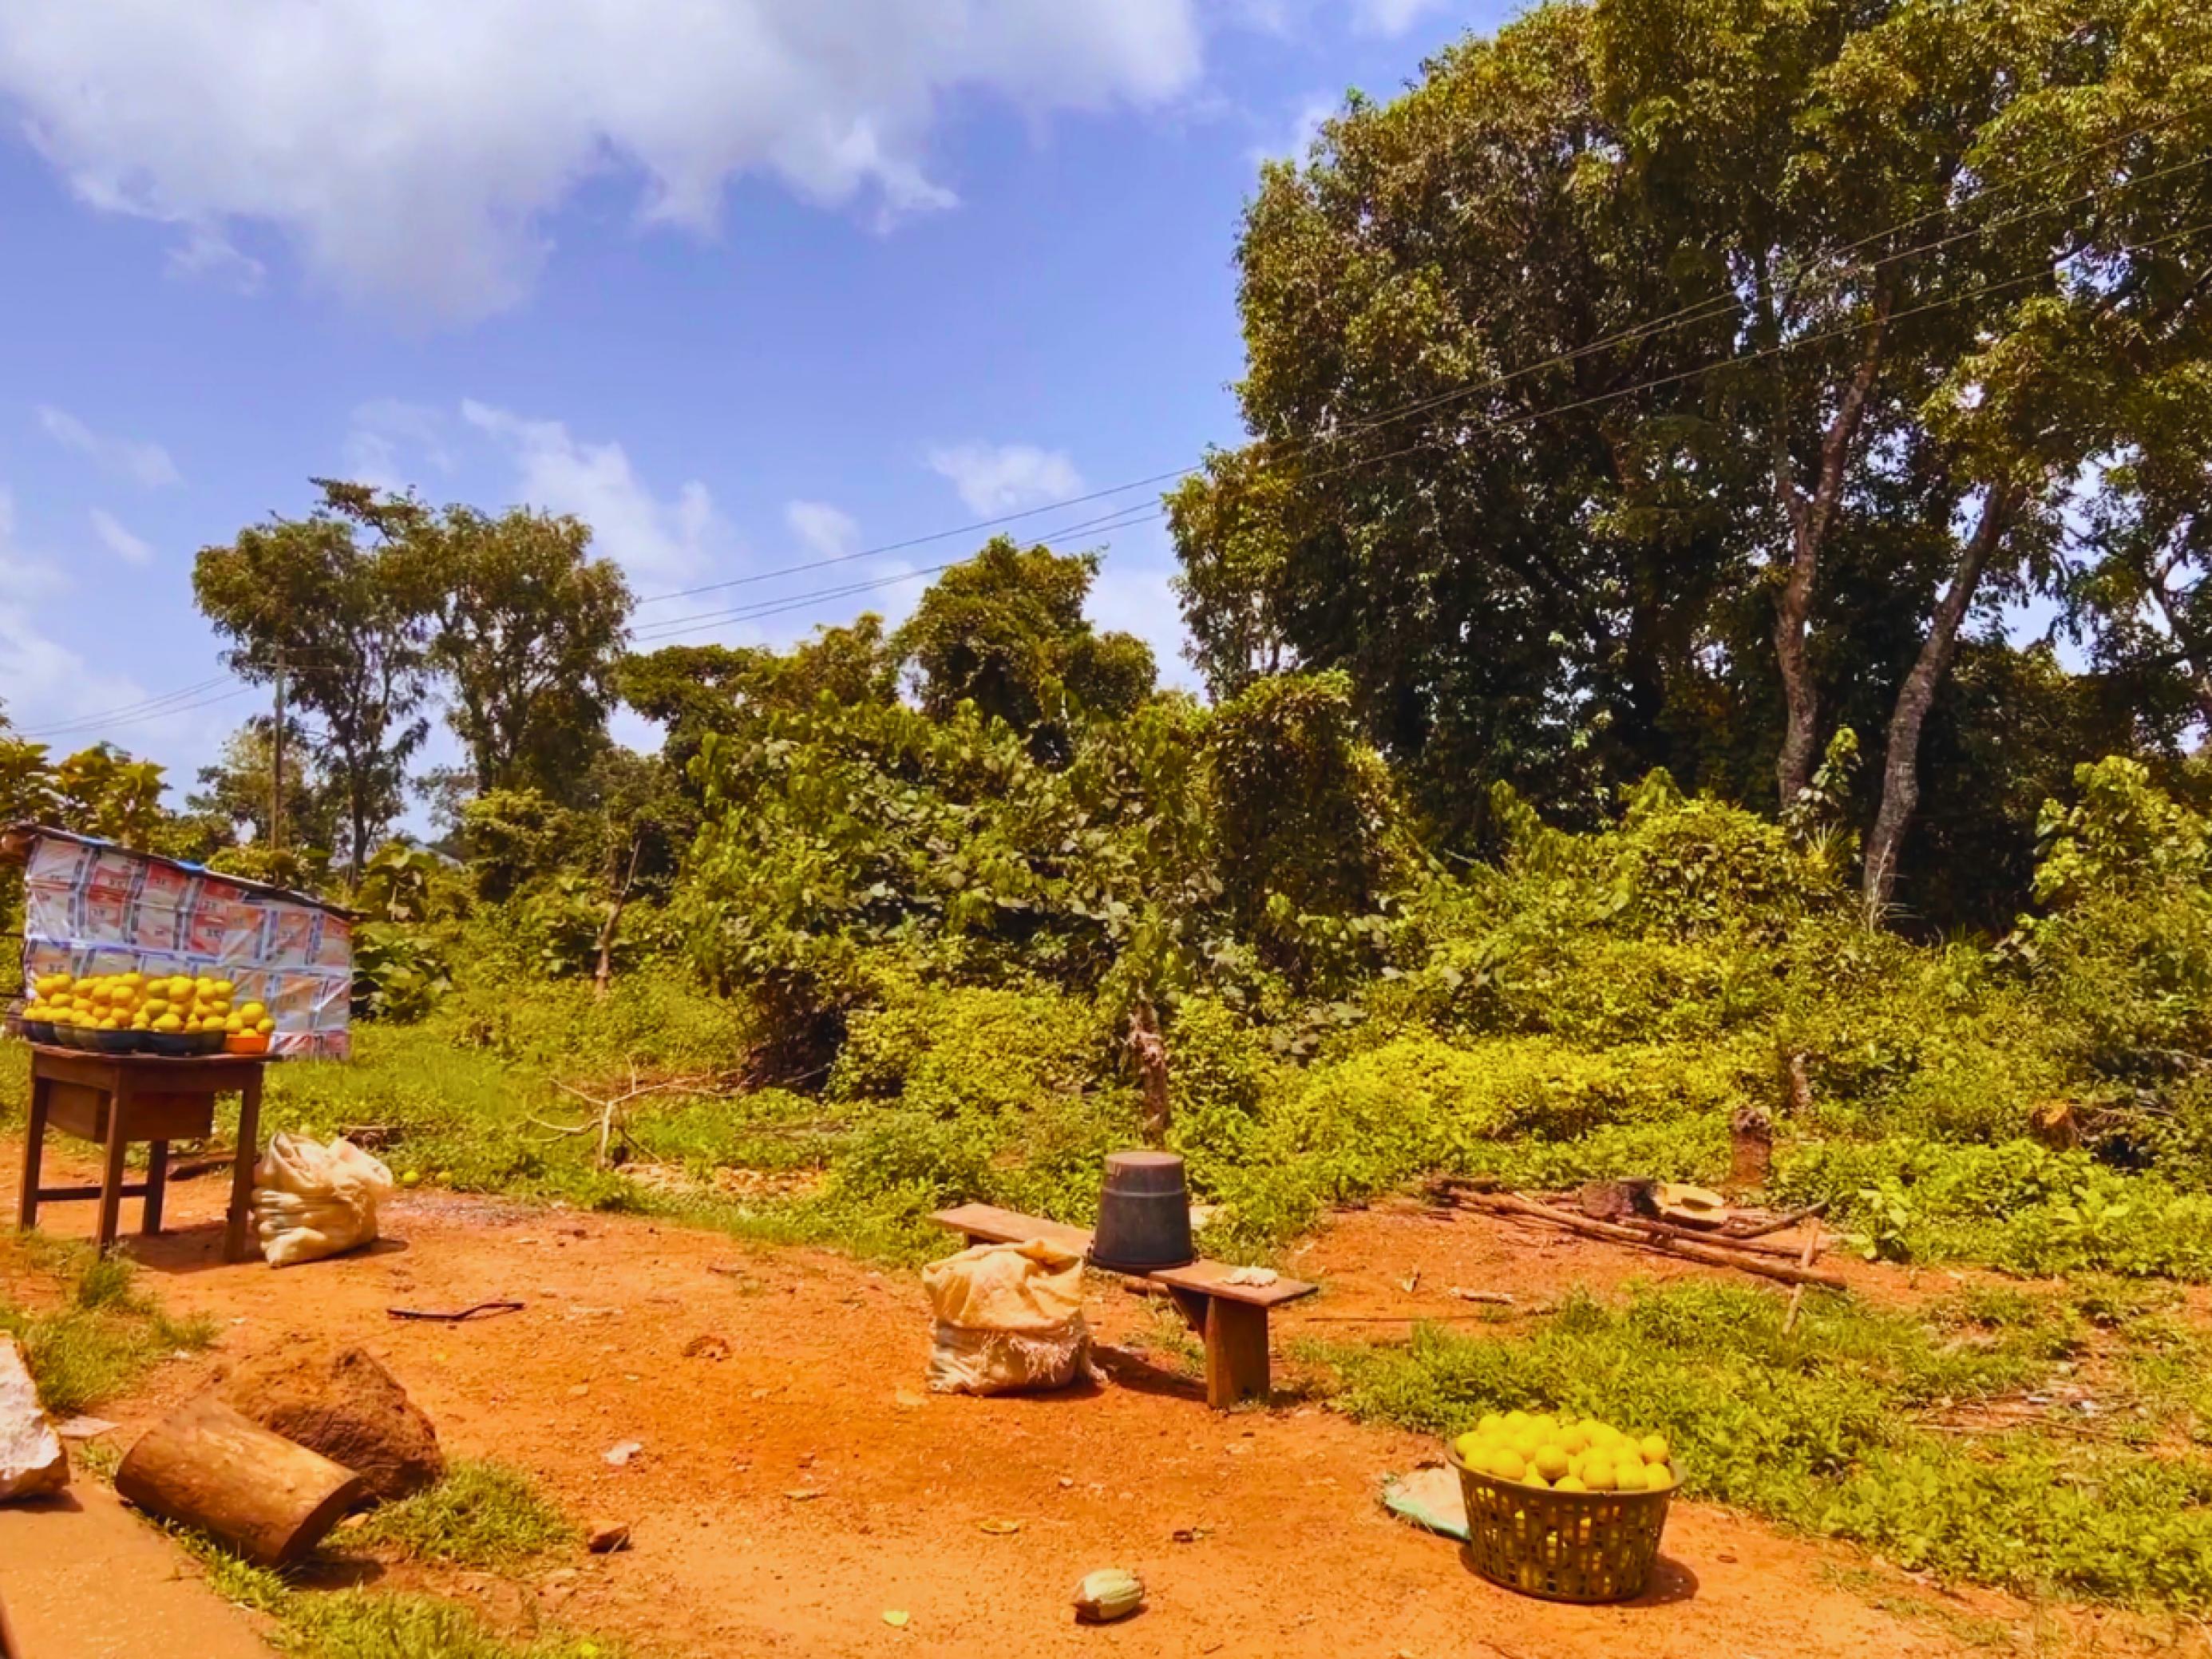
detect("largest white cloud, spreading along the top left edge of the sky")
[0,0,1212,319]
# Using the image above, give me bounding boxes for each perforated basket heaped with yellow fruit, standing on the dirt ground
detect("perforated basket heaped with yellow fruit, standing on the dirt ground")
[1444,1412,1675,1602]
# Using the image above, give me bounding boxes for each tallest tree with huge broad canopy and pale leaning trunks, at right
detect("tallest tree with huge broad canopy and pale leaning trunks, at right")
[1170,0,2212,912]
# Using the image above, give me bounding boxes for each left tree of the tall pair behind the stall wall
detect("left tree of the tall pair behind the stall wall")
[192,480,431,878]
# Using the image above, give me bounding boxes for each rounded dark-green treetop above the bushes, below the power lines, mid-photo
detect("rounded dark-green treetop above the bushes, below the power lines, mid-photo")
[892,536,1157,763]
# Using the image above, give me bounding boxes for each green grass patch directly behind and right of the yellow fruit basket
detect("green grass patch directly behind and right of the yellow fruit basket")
[1309,1283,2212,1610]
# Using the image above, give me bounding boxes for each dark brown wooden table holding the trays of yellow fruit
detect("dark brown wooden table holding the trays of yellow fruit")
[15,1042,267,1261]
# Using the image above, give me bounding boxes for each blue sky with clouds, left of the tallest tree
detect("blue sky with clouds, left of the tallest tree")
[0,0,1502,810]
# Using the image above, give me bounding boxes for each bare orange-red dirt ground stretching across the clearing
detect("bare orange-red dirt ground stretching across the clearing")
[0,1148,2197,1659]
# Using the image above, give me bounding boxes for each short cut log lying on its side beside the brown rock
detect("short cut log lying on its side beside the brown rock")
[115,1394,361,1566]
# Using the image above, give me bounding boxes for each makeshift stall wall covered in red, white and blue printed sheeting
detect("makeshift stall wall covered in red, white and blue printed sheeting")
[22,830,354,1059]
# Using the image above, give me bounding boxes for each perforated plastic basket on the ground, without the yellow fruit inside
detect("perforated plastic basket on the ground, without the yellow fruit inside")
[1444,1444,1675,1602]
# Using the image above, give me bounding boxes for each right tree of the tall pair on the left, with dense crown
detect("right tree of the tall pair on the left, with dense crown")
[405,506,631,798]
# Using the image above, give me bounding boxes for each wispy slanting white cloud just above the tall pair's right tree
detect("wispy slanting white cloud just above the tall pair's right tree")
[460,398,732,591]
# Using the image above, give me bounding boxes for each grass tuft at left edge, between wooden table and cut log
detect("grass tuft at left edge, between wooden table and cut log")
[0,1234,215,1415]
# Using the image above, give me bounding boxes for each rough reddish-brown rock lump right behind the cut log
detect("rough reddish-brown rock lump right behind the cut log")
[217,1336,445,1502]
